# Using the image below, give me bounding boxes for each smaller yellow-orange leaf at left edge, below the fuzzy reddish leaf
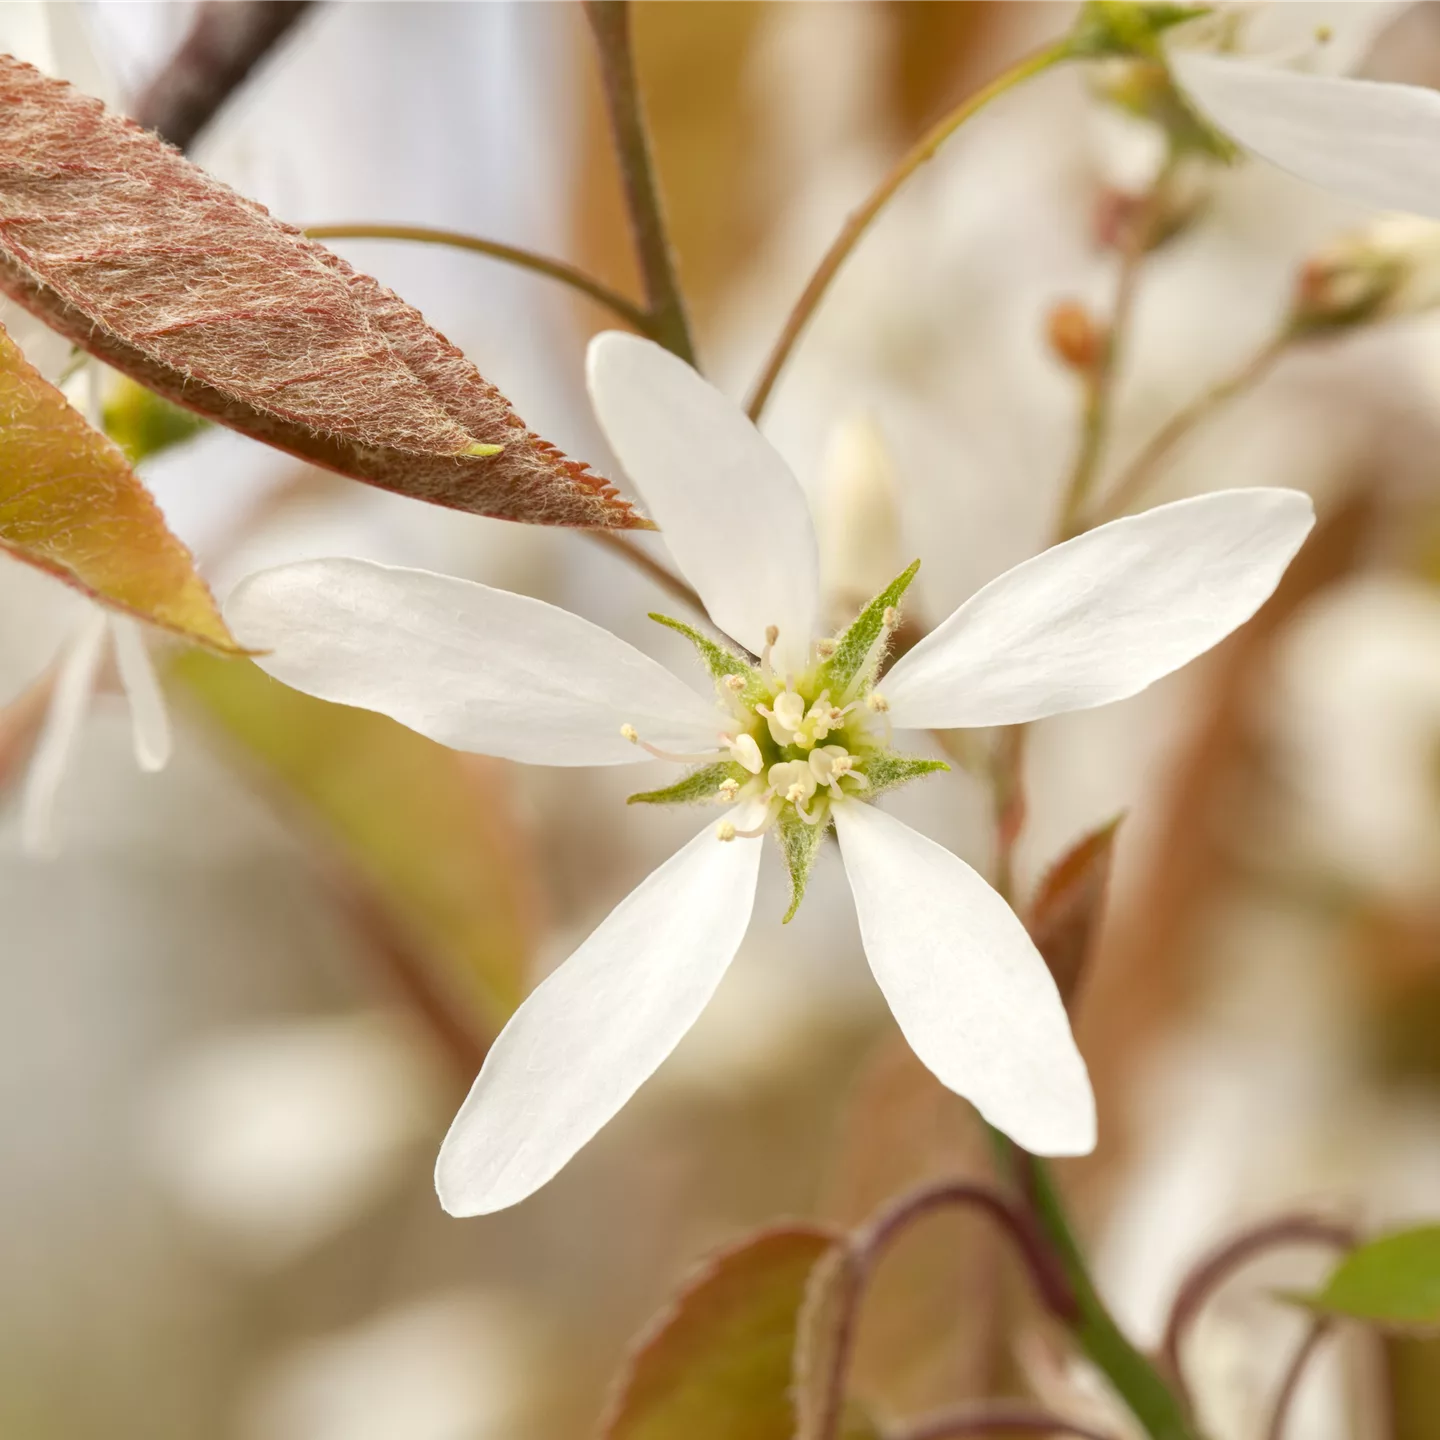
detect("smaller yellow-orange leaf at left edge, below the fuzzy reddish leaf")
[0,330,239,651]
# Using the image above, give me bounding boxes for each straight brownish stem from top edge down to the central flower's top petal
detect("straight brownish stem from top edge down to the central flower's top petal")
[585,0,696,364]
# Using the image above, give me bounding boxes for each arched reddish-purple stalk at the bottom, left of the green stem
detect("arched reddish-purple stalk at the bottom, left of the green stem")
[814,1181,1076,1440]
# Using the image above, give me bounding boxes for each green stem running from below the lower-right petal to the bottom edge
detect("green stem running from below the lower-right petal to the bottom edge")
[991,1130,1198,1440]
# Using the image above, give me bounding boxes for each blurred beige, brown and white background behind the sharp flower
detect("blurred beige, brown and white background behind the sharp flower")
[0,0,1440,1440]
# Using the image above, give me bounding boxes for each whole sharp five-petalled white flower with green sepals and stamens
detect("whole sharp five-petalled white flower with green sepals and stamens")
[226,334,1313,1215]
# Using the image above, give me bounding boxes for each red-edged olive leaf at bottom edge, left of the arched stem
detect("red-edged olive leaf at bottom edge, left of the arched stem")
[600,1225,838,1440]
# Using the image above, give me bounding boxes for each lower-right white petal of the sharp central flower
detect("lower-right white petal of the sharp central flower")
[834,801,1096,1155]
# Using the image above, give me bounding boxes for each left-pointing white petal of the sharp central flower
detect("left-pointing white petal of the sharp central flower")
[225,560,723,765]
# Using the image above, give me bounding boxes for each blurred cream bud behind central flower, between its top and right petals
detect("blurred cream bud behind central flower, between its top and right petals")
[816,415,904,618]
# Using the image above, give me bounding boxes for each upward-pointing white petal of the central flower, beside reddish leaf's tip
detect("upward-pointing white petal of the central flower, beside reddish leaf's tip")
[586,331,819,671]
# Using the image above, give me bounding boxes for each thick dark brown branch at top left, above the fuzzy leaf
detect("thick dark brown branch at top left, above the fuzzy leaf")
[131,0,321,150]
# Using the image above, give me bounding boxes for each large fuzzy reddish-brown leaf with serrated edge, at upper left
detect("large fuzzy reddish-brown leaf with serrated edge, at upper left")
[0,56,645,527]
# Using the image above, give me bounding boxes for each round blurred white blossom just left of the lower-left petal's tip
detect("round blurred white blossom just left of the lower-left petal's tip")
[145,1015,444,1266]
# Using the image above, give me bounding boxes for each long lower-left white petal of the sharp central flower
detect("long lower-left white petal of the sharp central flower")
[435,824,762,1215]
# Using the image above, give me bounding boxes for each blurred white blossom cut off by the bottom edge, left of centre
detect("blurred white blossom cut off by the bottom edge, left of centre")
[240,1292,536,1440]
